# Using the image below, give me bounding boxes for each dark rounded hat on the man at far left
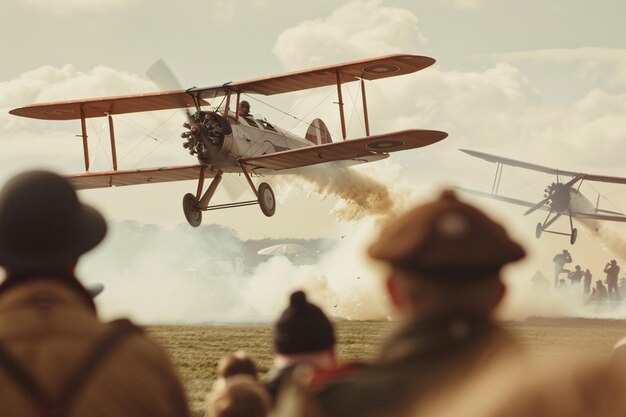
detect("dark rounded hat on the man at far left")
[0,171,107,270]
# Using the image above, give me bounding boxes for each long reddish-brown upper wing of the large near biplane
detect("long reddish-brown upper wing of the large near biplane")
[9,54,435,120]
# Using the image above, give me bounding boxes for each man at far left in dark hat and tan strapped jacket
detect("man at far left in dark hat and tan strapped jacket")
[0,171,189,417]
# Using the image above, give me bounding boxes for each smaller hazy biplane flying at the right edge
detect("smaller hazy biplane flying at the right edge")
[458,149,626,245]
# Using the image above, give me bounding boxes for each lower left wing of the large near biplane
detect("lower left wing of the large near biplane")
[65,165,213,190]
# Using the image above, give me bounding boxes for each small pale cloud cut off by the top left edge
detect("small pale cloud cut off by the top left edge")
[21,0,142,16]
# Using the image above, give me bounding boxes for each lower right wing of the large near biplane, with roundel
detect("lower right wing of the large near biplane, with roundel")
[240,130,448,170]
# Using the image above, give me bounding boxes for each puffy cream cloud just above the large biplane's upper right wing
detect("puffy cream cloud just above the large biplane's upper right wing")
[273,0,428,69]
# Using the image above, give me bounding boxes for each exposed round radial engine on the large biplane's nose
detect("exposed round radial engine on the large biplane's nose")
[180,110,232,165]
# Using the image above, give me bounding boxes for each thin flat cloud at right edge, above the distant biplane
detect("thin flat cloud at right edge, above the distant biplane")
[496,47,626,87]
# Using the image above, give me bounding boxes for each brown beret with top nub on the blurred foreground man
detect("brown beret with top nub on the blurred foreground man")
[368,190,526,280]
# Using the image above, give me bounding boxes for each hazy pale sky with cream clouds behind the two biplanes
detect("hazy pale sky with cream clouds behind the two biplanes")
[0,0,626,322]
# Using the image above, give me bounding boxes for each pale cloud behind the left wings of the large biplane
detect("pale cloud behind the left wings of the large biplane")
[0,64,190,176]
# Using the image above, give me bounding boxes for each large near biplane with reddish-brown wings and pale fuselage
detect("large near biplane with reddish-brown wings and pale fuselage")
[10,54,447,226]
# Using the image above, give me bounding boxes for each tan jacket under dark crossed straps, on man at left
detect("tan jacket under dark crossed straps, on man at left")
[0,279,189,417]
